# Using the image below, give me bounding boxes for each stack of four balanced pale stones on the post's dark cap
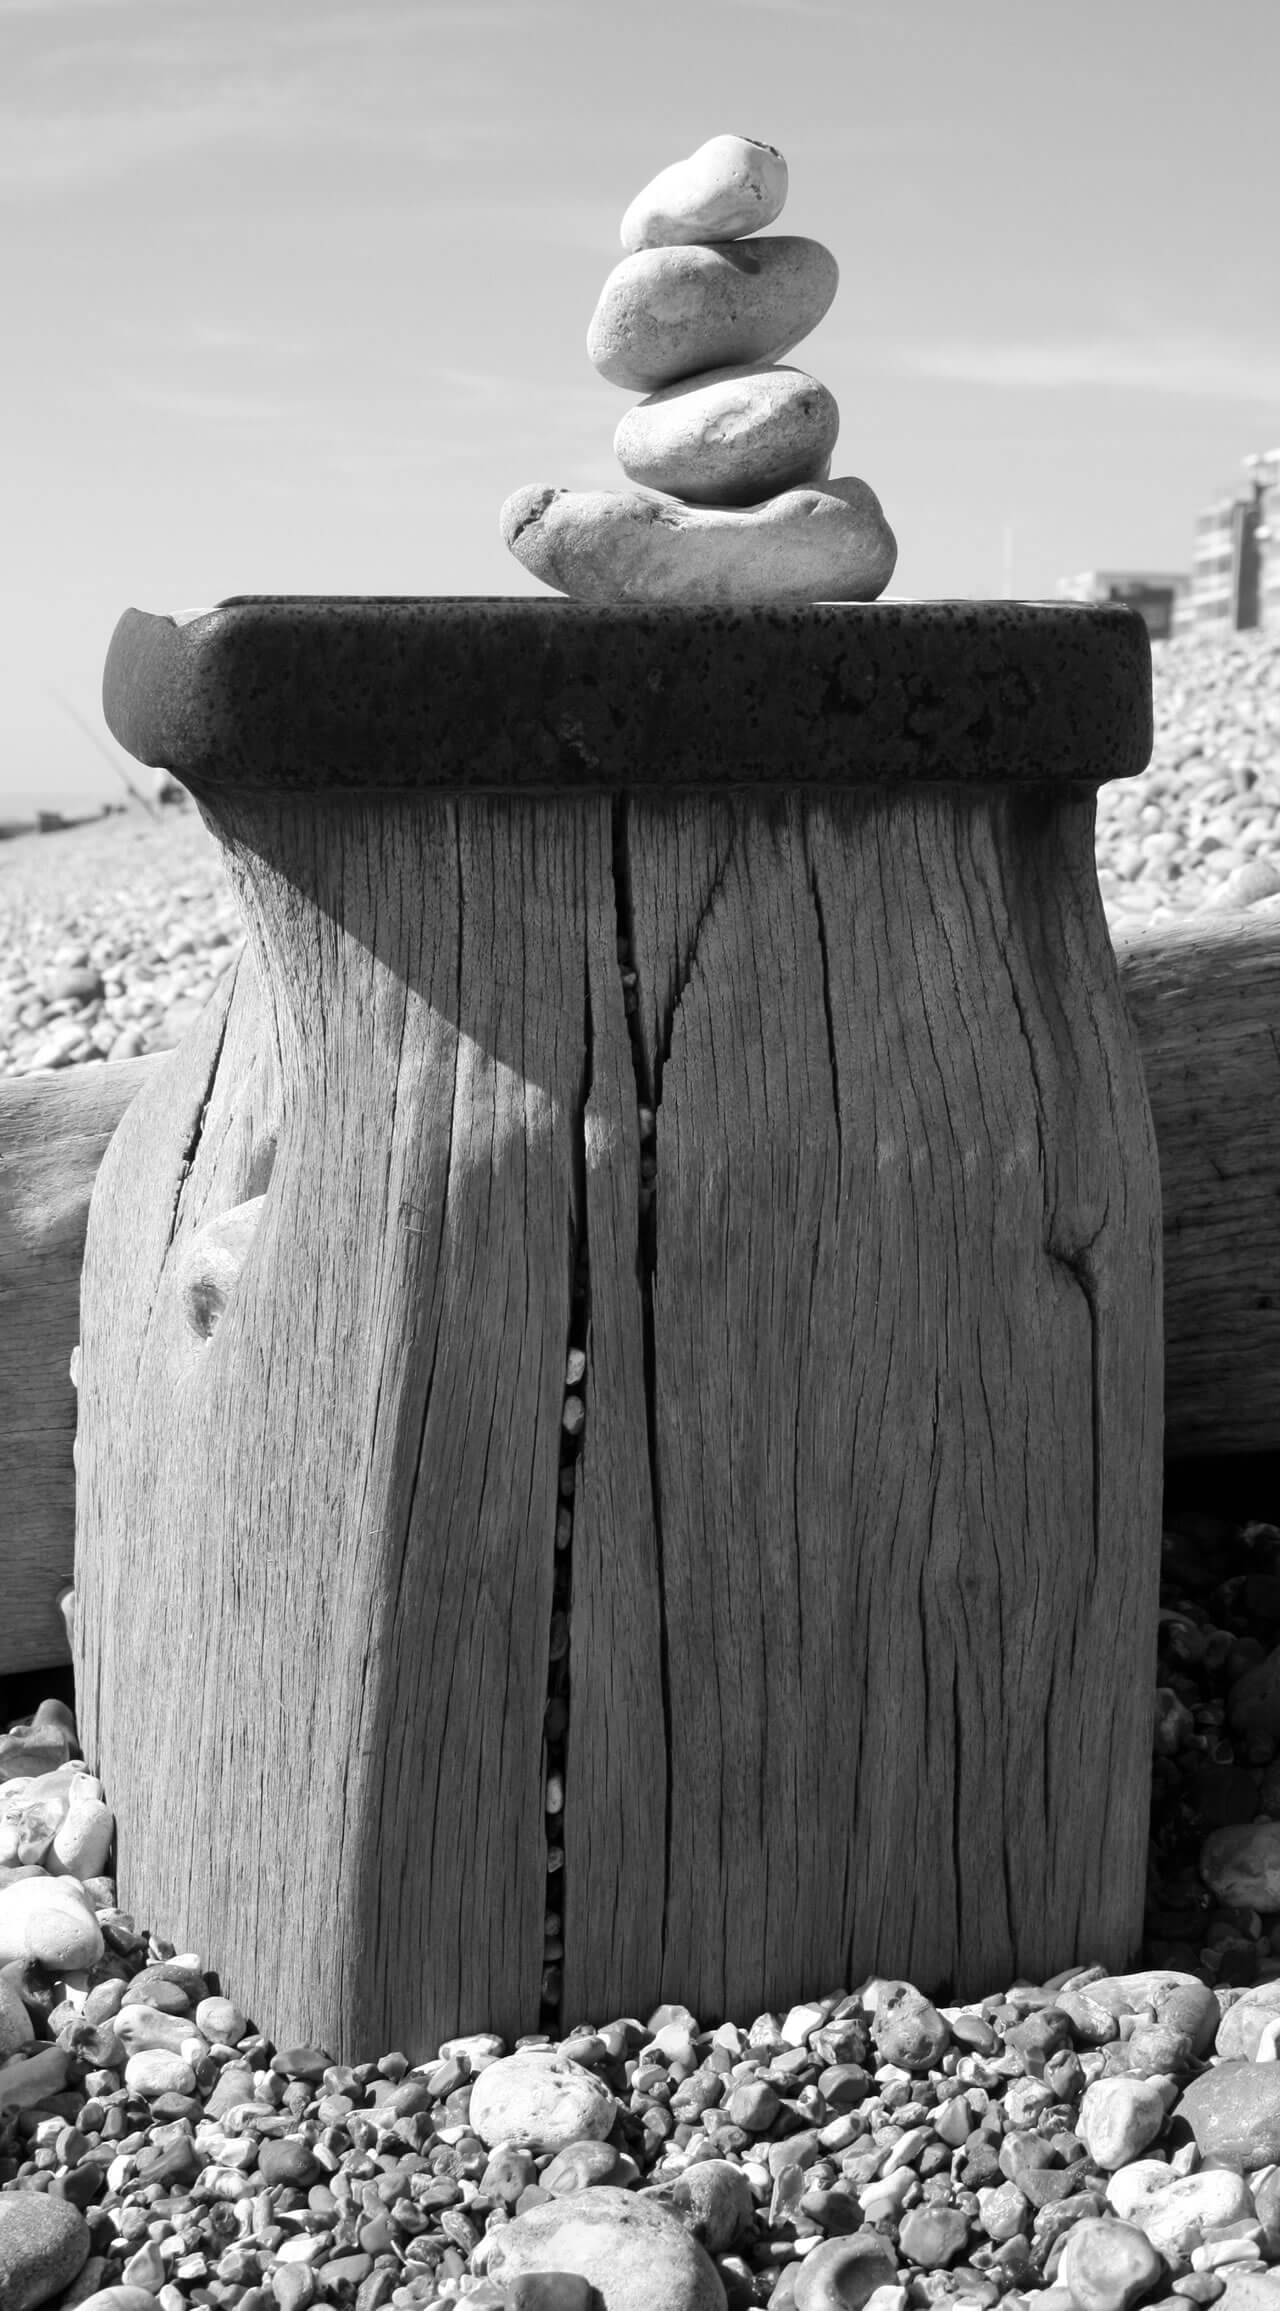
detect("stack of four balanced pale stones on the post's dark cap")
[492,136,896,603]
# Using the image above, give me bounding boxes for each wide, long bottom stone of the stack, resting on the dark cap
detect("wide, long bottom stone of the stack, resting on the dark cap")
[492,478,899,608]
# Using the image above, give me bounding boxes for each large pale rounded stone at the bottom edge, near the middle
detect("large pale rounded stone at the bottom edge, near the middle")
[471,2181,725,2311]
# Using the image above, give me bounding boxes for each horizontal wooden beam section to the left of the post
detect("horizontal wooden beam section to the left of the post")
[0,1056,164,1675]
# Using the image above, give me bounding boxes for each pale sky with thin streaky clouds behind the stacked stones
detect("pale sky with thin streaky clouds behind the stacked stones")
[0,0,1280,809]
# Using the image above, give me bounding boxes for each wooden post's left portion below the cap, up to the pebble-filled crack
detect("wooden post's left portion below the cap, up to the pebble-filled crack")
[76,802,585,2059]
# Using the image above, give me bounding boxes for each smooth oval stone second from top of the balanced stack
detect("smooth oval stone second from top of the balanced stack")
[587,233,839,393]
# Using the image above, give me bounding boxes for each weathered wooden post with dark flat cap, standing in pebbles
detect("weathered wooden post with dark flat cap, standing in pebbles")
[76,599,1162,2057]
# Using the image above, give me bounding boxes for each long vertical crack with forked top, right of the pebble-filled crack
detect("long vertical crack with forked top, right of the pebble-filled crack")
[612,795,674,1957]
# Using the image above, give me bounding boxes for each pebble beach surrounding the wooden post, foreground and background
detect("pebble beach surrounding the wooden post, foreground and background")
[0,636,1280,2311]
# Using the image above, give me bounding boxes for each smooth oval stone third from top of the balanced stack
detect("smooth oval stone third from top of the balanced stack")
[612,363,841,506]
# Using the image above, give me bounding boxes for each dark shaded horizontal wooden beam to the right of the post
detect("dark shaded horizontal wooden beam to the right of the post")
[1116,901,1280,1458]
